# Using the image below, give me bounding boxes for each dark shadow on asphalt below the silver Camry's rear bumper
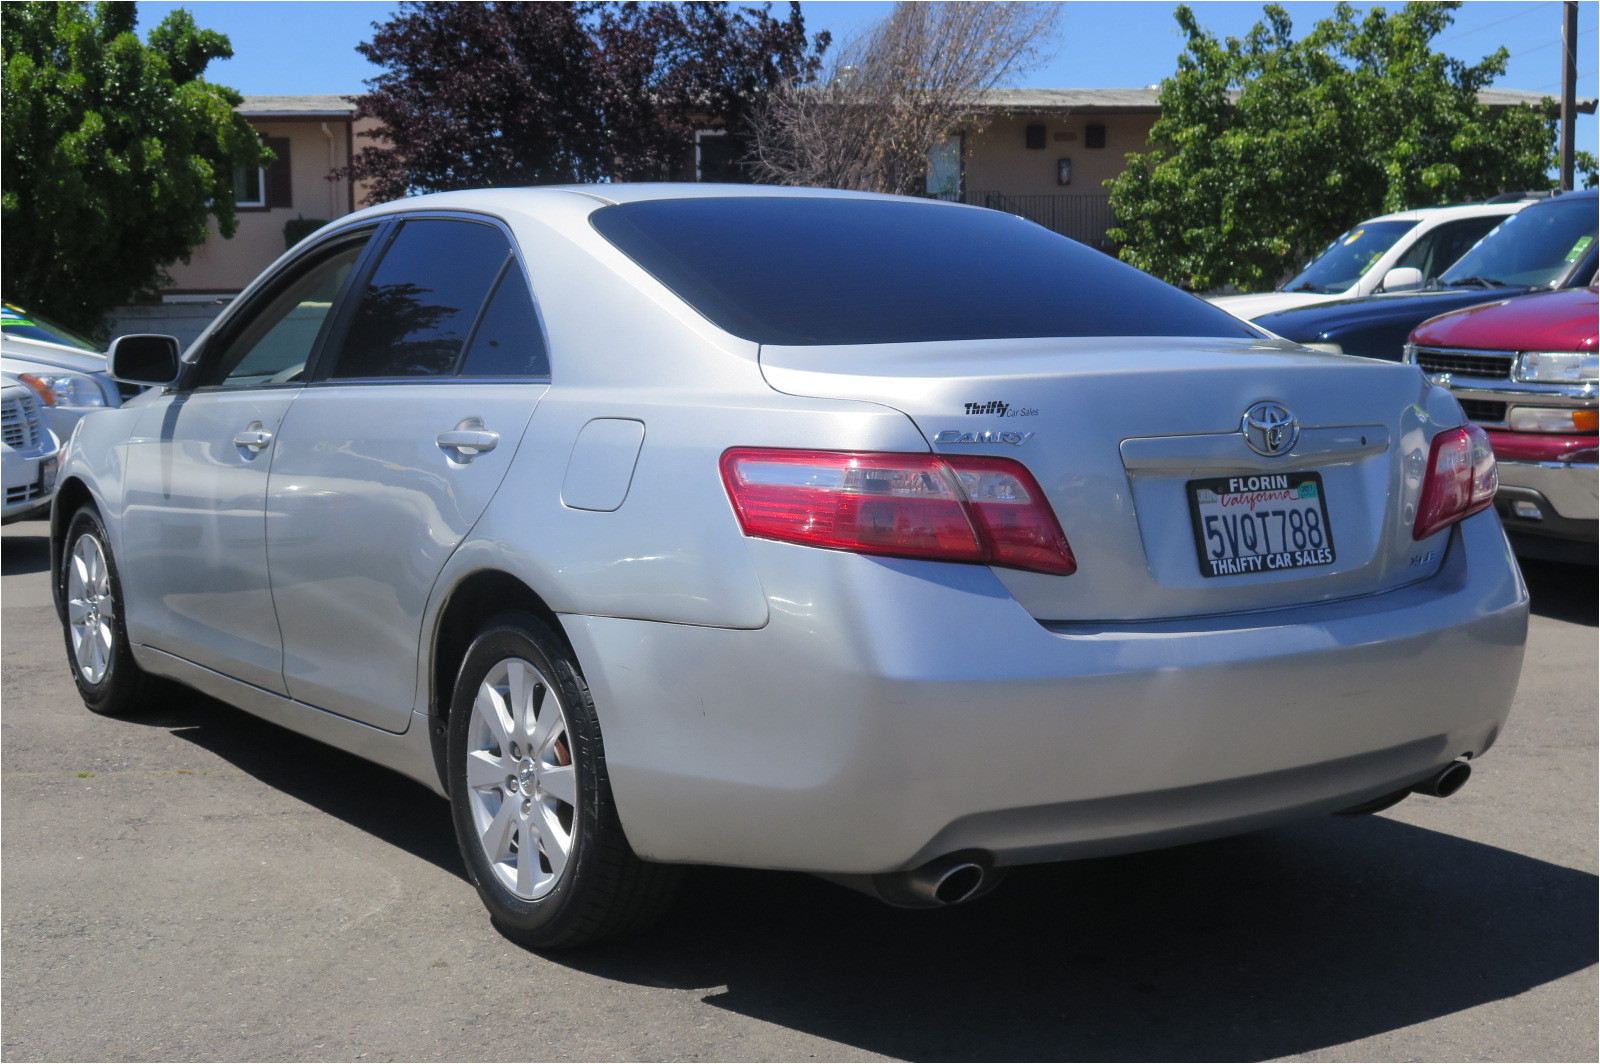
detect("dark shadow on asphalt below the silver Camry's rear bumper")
[552,818,1597,1061]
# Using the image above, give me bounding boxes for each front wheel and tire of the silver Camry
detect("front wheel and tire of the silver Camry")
[56,506,171,717]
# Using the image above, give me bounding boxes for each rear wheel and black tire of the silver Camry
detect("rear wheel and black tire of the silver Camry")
[448,611,682,949]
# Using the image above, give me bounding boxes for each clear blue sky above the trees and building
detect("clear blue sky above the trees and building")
[139,0,1600,154]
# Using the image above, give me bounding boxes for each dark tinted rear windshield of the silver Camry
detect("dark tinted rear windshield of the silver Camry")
[590,197,1259,346]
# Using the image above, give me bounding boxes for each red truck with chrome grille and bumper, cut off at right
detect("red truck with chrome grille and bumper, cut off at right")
[1405,285,1600,565]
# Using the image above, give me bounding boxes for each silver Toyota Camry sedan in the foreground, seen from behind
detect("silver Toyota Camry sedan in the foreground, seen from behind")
[53,184,1528,947]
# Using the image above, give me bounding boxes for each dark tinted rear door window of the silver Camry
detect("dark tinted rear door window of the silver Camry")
[330,218,510,379]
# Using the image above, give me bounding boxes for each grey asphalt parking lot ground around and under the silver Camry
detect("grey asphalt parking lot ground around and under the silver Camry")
[0,522,1597,1061]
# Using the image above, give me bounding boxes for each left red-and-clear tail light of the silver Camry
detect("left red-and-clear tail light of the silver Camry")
[722,448,1078,576]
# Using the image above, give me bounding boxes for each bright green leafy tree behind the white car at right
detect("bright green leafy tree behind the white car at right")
[1106,3,1580,290]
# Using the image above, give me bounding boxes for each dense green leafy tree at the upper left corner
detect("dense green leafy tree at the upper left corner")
[0,2,262,331]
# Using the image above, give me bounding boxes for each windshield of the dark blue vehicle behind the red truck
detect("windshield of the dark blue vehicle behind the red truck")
[1438,195,1597,288]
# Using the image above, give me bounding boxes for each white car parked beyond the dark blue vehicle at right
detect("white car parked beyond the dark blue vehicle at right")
[1206,197,1538,320]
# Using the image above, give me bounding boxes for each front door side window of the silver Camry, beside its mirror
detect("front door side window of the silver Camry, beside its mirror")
[197,230,371,387]
